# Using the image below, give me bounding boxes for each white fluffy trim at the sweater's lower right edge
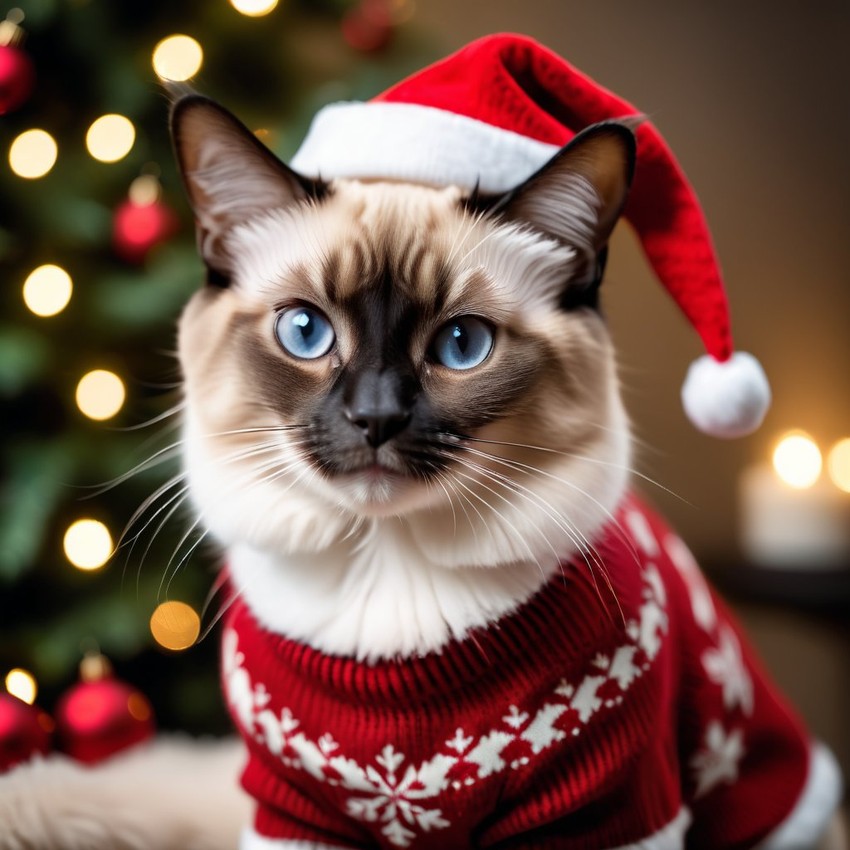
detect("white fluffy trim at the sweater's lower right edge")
[757,744,842,850]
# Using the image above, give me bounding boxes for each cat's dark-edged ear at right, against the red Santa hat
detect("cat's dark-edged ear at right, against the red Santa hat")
[480,122,635,274]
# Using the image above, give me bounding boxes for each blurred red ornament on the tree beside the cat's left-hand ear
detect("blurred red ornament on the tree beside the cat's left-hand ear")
[112,174,178,263]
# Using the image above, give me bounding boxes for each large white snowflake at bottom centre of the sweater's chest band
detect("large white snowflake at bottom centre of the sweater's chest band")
[342,744,457,847]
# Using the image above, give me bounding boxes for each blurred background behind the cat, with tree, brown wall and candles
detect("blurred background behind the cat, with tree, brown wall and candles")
[0,0,850,771]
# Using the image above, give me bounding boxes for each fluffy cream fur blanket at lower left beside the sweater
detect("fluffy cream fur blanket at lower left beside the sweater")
[0,736,250,850]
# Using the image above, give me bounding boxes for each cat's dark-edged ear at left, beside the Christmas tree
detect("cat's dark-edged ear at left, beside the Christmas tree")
[171,93,326,285]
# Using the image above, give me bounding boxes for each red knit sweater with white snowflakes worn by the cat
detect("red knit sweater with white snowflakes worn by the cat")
[223,498,820,850]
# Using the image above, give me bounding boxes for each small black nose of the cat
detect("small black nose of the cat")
[343,370,413,449]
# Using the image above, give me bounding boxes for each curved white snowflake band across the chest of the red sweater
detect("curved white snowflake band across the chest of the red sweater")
[223,528,667,847]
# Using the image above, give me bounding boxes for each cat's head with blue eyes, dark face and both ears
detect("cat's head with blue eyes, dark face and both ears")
[172,95,634,566]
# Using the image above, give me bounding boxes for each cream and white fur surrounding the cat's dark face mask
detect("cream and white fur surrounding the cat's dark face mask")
[180,181,630,659]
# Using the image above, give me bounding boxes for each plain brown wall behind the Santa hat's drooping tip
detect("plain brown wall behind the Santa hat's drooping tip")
[416,0,850,555]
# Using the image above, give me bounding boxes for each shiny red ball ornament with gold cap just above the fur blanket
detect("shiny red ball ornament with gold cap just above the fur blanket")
[55,652,154,764]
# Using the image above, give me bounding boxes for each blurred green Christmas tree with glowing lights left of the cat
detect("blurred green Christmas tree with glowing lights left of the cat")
[0,0,432,731]
